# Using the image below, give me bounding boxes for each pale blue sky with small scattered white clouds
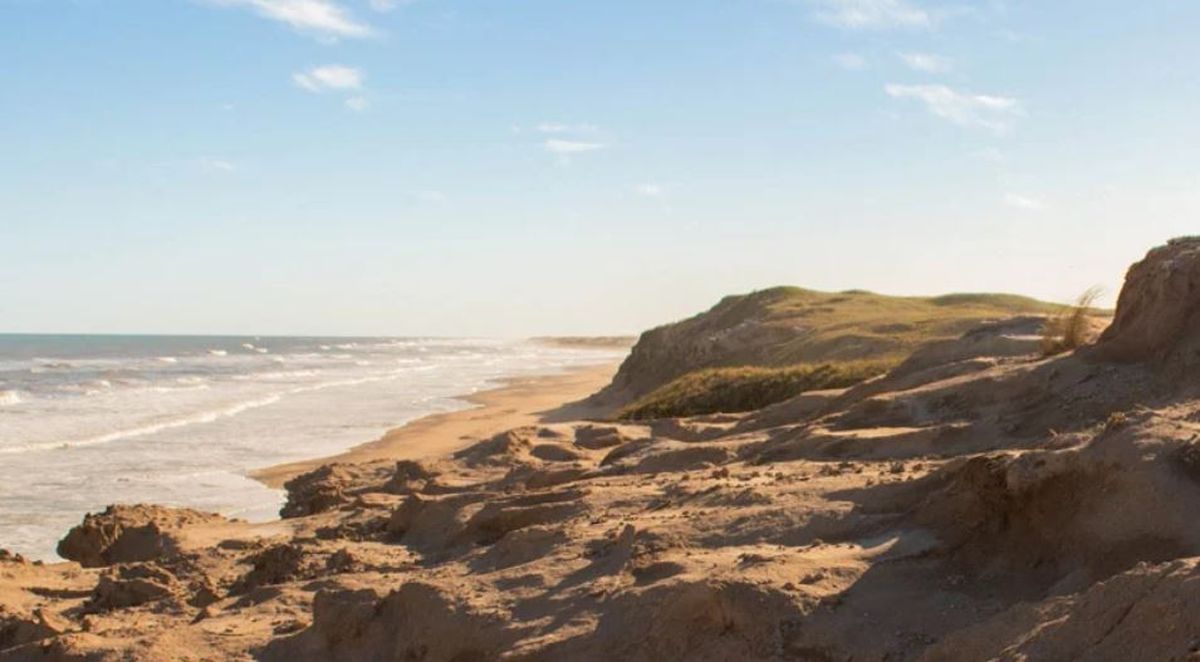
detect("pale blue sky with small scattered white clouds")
[0,0,1200,336]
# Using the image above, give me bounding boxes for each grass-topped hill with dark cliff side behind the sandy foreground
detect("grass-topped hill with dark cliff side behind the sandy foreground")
[596,288,1056,407]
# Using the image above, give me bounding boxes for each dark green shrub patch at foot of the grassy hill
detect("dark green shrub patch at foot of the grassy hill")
[618,361,890,421]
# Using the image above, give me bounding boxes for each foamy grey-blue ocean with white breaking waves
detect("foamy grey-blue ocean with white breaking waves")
[0,335,623,560]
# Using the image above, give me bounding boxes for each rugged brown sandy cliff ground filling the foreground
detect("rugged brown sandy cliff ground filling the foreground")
[11,242,1200,662]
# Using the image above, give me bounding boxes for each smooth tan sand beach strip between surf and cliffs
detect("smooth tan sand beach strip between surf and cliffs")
[247,360,620,489]
